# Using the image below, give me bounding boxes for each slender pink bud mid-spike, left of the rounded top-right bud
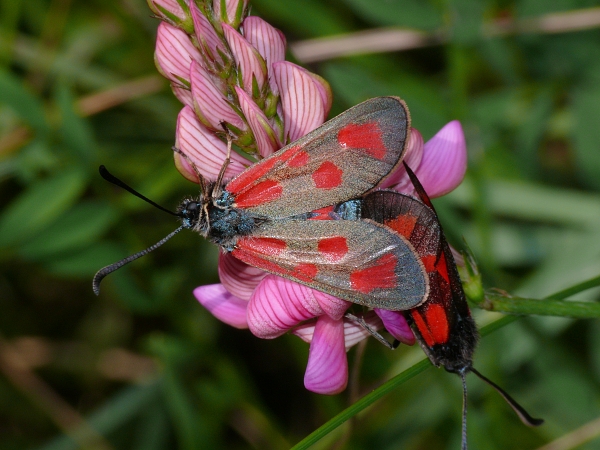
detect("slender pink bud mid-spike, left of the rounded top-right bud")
[222,23,267,95]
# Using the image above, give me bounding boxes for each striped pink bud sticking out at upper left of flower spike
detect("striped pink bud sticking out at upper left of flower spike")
[154,22,201,84]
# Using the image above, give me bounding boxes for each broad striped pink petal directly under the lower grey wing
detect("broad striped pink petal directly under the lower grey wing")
[248,275,323,339]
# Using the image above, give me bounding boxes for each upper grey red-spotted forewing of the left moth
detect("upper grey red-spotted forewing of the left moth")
[225,97,410,218]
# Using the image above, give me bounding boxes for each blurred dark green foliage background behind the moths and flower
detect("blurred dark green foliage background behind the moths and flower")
[0,0,600,450]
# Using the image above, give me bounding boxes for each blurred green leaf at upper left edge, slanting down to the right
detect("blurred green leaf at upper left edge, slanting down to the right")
[0,70,49,134]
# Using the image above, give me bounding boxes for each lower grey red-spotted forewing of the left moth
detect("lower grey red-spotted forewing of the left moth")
[232,220,429,310]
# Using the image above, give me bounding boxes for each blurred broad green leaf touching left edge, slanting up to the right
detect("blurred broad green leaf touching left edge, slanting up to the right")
[0,169,85,248]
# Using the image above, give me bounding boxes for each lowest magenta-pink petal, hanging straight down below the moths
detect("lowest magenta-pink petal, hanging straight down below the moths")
[304,316,348,395]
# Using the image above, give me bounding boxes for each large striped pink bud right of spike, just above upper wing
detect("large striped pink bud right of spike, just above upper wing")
[273,61,325,143]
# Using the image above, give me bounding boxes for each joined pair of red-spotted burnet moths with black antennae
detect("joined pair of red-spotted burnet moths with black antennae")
[93,97,541,448]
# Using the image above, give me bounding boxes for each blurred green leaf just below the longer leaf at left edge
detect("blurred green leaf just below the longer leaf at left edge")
[19,202,116,259]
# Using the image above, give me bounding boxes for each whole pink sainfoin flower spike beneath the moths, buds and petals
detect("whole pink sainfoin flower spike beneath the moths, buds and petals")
[149,0,466,394]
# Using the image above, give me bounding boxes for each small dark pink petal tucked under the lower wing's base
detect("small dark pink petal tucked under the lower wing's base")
[219,253,267,300]
